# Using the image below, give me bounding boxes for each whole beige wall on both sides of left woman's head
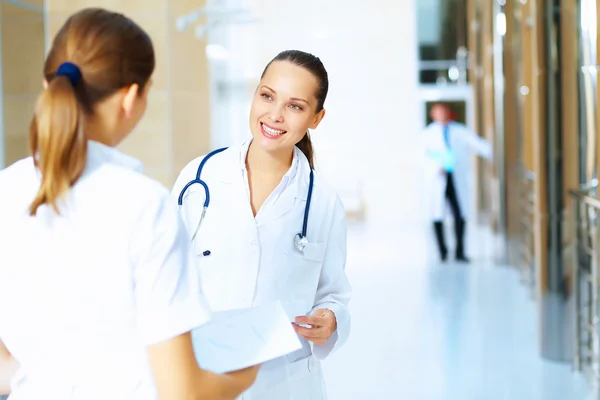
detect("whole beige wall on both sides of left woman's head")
[0,0,210,186]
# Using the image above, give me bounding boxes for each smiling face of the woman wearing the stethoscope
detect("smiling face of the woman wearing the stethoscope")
[250,61,325,153]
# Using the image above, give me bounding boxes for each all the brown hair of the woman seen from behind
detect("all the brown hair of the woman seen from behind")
[29,8,155,216]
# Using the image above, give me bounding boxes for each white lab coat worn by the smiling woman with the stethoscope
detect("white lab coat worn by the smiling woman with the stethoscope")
[173,142,351,400]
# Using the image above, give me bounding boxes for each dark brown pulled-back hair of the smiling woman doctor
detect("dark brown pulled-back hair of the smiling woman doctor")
[261,50,329,169]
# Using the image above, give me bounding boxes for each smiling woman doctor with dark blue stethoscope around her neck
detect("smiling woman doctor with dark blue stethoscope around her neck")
[173,51,351,400]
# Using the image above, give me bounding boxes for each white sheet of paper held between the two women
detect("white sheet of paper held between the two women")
[192,302,302,374]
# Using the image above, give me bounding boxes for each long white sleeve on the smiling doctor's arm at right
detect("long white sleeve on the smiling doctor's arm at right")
[311,197,352,360]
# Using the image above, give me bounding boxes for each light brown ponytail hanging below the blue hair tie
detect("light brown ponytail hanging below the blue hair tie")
[29,75,87,216]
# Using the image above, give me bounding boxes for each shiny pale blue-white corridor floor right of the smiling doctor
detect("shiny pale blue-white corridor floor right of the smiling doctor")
[324,224,591,400]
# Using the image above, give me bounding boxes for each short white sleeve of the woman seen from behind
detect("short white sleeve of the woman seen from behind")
[130,193,210,345]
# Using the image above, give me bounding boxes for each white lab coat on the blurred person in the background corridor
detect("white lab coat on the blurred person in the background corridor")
[423,122,492,221]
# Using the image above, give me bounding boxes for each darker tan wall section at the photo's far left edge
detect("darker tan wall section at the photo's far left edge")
[0,0,44,165]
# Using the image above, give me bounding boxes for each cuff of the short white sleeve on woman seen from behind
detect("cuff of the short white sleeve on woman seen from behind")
[138,299,211,346]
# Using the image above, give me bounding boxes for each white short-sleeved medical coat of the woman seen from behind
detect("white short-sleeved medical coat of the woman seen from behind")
[0,141,210,400]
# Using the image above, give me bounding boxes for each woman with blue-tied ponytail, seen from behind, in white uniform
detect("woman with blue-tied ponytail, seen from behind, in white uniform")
[0,8,258,400]
